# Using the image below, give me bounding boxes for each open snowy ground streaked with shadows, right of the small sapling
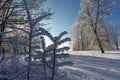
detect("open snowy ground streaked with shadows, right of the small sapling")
[63,51,120,80]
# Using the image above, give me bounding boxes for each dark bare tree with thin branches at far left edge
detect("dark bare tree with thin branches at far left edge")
[0,0,15,52]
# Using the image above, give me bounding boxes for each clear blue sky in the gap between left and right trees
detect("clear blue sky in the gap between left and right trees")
[45,0,80,35]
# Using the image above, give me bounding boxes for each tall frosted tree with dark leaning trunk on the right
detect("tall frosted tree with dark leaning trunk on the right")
[80,0,115,53]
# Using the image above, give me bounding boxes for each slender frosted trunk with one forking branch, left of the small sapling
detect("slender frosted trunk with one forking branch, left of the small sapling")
[23,0,52,80]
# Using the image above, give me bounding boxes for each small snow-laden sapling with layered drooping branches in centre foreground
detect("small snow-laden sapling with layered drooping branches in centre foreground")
[40,28,72,80]
